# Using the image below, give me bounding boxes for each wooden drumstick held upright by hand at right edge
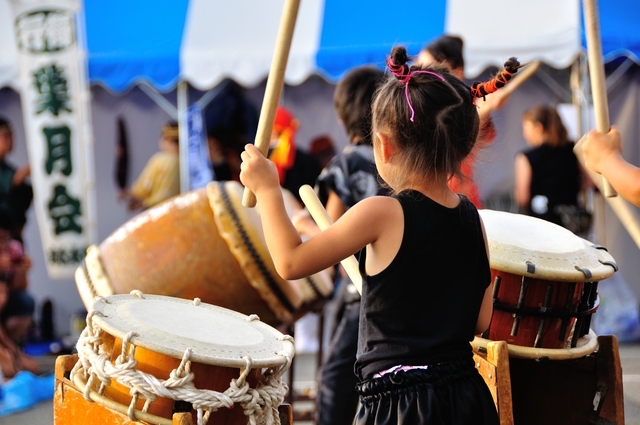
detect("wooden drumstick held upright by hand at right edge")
[574,0,618,198]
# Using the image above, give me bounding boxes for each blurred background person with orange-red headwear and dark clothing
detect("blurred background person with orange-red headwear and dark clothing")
[268,106,322,206]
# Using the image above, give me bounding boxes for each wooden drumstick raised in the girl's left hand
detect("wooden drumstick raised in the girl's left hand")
[242,0,300,208]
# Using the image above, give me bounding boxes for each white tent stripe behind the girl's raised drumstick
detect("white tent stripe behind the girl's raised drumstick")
[180,0,324,90]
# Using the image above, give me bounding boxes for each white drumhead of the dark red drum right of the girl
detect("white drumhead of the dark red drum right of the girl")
[479,210,617,282]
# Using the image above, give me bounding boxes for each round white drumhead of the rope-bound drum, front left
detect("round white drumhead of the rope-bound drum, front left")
[93,295,294,368]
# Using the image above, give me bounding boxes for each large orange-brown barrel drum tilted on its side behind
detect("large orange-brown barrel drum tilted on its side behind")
[75,181,332,326]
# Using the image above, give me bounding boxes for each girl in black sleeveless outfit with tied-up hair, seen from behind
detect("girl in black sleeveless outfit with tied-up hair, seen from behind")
[240,47,499,425]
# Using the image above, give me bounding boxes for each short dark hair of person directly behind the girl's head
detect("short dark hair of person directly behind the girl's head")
[333,66,385,145]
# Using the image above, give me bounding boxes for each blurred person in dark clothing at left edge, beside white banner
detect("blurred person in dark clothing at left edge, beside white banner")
[0,117,33,241]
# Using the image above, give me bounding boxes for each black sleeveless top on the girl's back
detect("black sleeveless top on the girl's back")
[356,191,491,379]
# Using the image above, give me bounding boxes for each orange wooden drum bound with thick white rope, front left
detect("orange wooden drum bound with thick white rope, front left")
[70,291,294,425]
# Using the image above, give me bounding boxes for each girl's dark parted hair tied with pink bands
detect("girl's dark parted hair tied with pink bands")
[373,47,480,182]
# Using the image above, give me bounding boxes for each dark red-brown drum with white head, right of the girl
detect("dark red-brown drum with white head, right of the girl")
[480,210,617,349]
